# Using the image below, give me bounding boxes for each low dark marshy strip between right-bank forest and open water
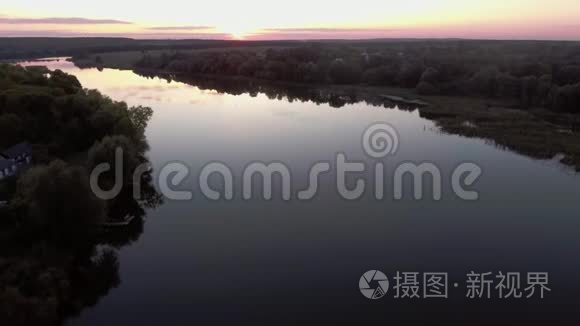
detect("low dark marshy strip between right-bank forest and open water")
[135,70,580,171]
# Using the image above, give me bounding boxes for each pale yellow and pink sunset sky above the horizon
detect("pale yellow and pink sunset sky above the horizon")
[0,0,580,40]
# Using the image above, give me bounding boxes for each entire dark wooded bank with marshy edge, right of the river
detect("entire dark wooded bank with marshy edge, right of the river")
[71,40,580,171]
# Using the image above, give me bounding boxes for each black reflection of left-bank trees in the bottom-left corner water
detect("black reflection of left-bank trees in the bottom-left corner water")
[0,191,159,325]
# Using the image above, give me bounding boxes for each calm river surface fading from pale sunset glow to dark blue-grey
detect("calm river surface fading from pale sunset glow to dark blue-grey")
[18,61,580,325]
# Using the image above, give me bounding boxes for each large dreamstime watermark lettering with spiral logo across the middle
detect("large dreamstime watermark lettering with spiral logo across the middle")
[90,122,482,201]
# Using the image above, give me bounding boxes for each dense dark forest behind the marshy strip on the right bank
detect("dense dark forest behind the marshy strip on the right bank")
[129,40,580,113]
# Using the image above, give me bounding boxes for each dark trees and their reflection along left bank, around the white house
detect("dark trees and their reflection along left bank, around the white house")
[0,64,161,325]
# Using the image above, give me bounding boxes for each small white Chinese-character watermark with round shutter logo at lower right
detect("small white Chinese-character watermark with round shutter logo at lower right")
[359,270,552,300]
